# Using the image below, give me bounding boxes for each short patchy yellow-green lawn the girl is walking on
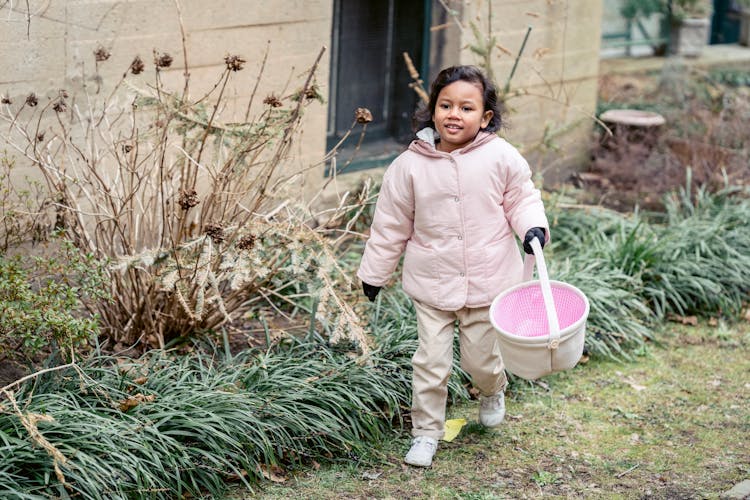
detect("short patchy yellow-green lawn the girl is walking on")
[251,323,750,499]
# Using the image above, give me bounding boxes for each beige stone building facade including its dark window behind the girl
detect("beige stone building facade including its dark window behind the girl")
[0,0,602,188]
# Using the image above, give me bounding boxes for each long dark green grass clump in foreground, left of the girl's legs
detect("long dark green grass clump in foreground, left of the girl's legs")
[0,321,465,499]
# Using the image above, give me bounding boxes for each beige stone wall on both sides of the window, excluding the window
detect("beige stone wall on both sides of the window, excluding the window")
[0,0,602,193]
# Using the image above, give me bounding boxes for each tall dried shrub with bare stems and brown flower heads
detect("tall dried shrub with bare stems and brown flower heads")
[0,46,367,349]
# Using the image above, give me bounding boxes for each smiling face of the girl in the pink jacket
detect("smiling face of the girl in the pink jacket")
[432,80,492,153]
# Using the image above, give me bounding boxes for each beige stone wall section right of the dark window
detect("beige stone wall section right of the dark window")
[461,0,602,185]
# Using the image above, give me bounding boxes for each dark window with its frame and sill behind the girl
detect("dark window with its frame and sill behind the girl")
[327,0,432,171]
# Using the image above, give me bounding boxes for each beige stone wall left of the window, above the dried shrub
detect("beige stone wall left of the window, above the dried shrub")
[0,0,332,191]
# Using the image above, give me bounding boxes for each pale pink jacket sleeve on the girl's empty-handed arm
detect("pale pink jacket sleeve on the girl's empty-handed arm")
[357,163,414,286]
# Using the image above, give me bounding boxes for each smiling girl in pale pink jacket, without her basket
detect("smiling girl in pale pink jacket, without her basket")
[357,66,549,467]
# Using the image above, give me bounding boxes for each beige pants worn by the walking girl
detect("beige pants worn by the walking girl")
[411,300,507,439]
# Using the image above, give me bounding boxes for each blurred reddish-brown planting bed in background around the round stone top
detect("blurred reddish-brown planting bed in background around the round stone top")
[575,69,750,211]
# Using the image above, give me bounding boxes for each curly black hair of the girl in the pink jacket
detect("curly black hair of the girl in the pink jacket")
[413,66,505,132]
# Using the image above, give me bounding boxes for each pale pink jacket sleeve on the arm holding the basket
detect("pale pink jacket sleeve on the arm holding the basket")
[503,149,550,241]
